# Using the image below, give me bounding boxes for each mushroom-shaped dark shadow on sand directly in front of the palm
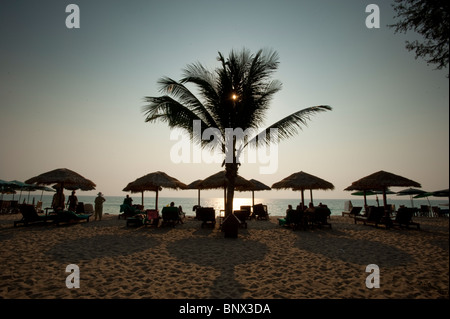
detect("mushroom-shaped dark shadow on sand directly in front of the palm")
[167,237,268,299]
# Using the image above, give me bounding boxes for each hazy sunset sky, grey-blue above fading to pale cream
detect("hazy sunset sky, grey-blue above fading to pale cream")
[0,0,449,199]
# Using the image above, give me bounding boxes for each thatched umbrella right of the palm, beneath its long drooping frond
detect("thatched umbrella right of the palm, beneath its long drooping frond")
[272,171,334,205]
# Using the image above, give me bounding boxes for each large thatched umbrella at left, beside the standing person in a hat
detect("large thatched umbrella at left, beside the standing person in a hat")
[25,168,96,209]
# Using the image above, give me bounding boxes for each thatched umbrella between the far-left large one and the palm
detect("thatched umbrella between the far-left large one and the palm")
[123,171,187,209]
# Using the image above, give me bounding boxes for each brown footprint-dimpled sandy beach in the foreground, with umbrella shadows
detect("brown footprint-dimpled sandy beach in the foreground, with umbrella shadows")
[0,215,449,299]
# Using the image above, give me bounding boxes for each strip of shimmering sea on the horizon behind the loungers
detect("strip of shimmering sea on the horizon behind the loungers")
[3,193,448,216]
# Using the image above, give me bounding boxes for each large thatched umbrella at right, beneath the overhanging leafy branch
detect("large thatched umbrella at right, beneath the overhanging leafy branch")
[345,171,422,209]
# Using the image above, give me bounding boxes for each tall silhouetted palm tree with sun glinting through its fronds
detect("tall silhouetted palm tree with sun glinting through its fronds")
[143,49,331,215]
